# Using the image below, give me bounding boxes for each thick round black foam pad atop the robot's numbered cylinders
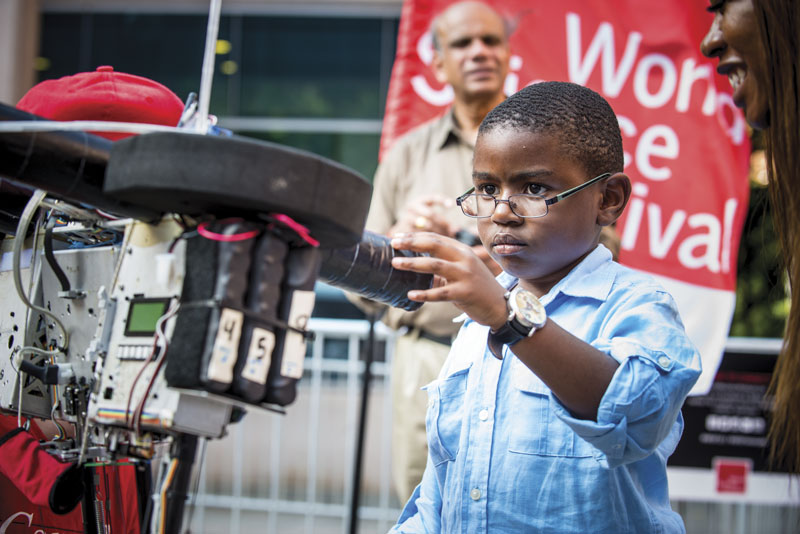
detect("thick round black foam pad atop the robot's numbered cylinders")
[103,132,372,248]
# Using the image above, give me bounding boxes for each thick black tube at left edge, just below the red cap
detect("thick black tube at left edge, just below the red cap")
[0,104,160,221]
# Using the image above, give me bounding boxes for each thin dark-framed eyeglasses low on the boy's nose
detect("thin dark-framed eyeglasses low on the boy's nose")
[456,172,611,219]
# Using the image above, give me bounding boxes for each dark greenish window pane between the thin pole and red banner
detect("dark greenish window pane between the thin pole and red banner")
[241,17,394,118]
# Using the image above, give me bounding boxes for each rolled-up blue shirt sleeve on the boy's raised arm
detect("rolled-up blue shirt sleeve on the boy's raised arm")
[553,292,700,468]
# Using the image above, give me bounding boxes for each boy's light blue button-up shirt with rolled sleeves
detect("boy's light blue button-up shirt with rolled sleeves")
[392,245,700,534]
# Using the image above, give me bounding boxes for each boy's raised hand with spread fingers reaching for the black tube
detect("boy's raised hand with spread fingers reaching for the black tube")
[392,232,508,330]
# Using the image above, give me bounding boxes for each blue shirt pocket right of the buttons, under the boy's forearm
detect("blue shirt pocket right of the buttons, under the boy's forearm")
[508,360,596,458]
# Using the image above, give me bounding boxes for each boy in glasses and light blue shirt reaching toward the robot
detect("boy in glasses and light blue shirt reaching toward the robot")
[392,82,700,534]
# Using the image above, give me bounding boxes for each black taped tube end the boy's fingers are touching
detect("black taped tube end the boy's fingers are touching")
[319,232,433,311]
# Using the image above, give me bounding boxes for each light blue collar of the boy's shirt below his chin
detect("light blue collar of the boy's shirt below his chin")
[497,245,614,305]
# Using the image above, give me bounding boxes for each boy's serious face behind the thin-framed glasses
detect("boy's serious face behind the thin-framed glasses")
[473,127,602,294]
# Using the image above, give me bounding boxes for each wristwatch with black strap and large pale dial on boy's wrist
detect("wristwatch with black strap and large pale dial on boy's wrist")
[487,285,547,360]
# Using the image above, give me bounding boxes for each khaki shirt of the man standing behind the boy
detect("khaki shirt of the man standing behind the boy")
[366,109,477,336]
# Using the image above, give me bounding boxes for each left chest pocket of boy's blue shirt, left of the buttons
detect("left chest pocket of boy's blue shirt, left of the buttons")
[423,363,472,466]
